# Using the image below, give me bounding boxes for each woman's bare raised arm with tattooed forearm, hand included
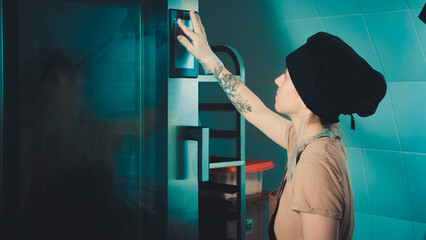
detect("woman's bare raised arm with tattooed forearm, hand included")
[178,10,291,149]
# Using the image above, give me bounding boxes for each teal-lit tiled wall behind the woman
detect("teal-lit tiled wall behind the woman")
[199,0,426,240]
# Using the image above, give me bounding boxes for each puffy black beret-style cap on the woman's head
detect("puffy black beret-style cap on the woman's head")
[286,32,387,129]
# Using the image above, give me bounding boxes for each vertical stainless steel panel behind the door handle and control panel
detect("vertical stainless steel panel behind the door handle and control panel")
[167,0,198,239]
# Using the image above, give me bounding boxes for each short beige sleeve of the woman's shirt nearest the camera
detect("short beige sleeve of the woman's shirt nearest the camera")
[290,159,344,219]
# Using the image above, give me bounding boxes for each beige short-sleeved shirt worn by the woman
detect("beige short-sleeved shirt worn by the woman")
[274,124,354,240]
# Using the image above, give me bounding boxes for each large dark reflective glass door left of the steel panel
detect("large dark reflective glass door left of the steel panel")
[1,0,171,239]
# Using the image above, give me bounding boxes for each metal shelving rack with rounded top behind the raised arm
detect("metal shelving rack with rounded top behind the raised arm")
[198,45,246,240]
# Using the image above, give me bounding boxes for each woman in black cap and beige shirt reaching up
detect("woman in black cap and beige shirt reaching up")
[178,10,386,240]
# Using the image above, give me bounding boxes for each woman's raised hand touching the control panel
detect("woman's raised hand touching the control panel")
[177,9,223,73]
